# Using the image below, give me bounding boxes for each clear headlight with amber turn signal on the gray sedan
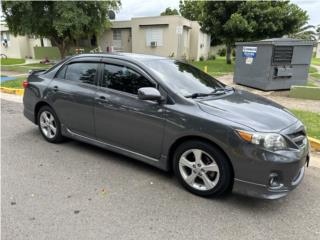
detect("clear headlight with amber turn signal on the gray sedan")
[237,130,287,150]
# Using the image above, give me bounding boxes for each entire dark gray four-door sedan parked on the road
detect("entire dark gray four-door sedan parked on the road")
[23,53,309,199]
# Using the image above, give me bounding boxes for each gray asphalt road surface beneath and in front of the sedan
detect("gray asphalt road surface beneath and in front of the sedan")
[1,100,320,240]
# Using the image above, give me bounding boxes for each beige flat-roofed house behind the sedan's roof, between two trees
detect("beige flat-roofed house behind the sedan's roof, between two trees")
[98,16,210,60]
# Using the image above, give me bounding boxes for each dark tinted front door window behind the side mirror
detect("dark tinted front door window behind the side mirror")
[101,64,156,94]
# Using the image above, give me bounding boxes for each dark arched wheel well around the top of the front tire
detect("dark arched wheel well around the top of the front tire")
[168,136,234,179]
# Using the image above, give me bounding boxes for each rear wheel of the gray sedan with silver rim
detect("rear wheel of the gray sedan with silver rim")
[37,106,64,143]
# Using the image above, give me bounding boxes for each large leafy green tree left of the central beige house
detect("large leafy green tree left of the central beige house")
[2,0,120,58]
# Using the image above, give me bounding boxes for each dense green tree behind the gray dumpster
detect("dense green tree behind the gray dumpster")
[180,1,308,64]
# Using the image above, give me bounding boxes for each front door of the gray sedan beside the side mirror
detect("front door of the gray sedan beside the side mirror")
[95,61,165,159]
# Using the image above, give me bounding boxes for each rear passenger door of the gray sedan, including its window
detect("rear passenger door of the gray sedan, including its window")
[49,58,99,137]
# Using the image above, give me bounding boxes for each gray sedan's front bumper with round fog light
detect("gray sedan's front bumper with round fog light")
[233,122,309,199]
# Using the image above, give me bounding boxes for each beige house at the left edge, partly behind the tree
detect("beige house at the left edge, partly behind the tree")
[0,22,51,58]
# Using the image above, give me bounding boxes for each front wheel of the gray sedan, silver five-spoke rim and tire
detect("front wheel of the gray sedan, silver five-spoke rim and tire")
[173,140,233,197]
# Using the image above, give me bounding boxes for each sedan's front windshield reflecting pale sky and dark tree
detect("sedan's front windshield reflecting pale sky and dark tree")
[144,60,224,96]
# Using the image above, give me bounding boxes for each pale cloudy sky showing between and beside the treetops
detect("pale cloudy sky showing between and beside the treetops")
[116,0,320,25]
